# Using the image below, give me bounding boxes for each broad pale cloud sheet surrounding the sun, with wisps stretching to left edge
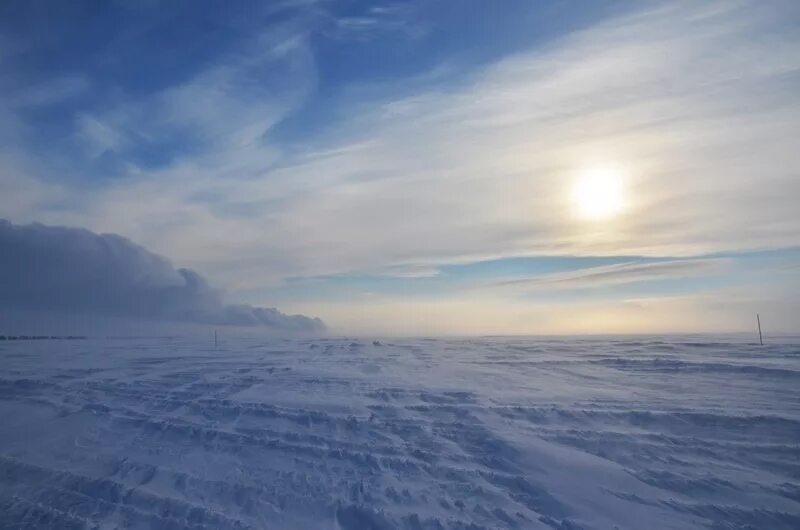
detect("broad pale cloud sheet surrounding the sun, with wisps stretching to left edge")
[0,2,800,291]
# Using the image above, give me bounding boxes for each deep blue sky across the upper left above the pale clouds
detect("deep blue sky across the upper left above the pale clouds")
[2,1,614,181]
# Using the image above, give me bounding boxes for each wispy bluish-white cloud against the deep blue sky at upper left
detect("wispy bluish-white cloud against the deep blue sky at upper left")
[71,24,315,169]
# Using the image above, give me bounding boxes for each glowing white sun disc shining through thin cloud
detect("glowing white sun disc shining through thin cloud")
[572,168,625,221]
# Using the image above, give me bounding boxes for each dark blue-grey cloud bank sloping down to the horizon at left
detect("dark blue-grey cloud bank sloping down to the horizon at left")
[0,219,325,332]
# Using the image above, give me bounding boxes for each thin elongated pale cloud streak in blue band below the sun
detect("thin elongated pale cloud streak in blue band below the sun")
[492,258,729,289]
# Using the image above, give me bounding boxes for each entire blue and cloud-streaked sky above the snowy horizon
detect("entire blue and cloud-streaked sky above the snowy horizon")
[0,0,800,335]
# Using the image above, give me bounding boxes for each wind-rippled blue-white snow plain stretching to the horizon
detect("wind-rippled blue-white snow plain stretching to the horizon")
[0,337,800,530]
